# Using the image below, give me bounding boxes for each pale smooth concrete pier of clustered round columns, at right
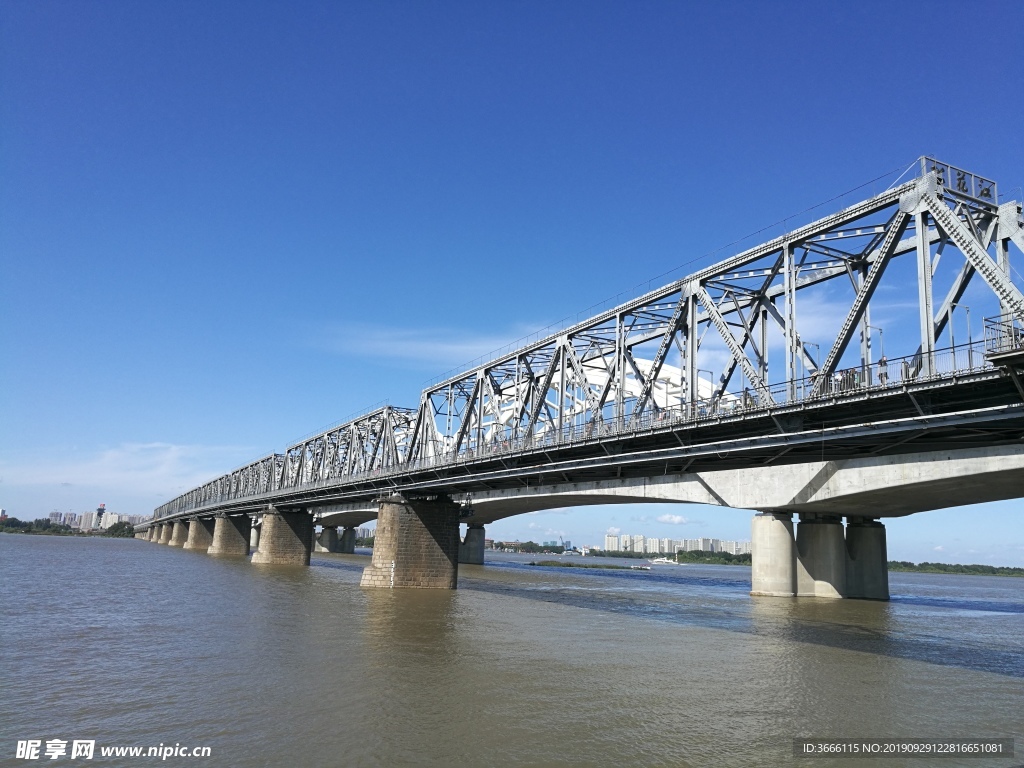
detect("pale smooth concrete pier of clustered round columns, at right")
[751,512,889,600]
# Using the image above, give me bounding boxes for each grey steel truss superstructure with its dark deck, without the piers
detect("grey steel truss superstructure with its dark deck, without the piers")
[154,158,1024,520]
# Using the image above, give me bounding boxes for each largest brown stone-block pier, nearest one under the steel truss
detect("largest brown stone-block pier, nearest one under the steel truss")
[359,494,459,590]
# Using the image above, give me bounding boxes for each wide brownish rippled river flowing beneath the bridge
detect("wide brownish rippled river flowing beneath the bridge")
[0,535,1024,768]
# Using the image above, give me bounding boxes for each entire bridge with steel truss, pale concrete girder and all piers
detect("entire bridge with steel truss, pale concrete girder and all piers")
[136,158,1024,599]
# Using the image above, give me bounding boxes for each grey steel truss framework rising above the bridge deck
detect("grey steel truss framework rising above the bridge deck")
[157,158,1024,517]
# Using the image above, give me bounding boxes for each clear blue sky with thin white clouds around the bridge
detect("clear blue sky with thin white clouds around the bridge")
[0,0,1024,565]
